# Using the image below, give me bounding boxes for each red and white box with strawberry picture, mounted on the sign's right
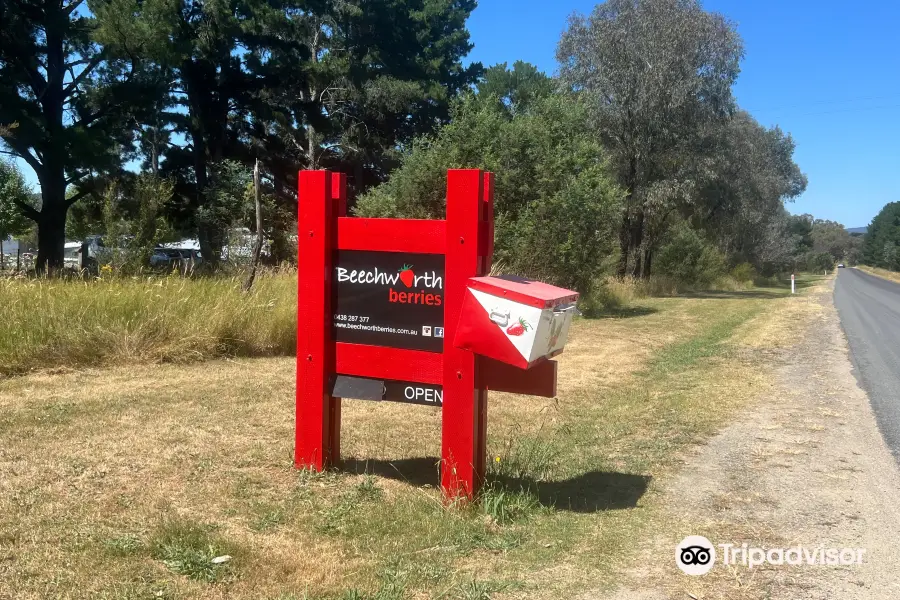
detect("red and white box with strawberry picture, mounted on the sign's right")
[454,276,578,369]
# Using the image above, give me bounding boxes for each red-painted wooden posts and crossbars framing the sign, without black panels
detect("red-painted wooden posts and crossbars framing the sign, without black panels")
[295,169,556,498]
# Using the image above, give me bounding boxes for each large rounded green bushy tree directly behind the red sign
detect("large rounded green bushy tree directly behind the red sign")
[355,95,623,293]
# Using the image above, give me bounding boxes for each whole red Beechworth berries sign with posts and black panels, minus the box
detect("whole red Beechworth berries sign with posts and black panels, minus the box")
[295,169,572,498]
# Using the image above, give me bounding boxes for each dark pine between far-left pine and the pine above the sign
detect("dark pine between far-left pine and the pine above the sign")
[102,0,260,265]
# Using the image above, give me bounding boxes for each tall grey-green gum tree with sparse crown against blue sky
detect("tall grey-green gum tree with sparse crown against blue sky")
[557,0,743,275]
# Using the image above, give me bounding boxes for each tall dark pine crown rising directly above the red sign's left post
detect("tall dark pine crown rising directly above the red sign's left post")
[248,0,481,198]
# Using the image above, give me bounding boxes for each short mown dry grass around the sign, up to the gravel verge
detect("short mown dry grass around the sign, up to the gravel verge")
[0,278,816,599]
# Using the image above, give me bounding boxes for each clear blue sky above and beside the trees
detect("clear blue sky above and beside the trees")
[469,0,900,227]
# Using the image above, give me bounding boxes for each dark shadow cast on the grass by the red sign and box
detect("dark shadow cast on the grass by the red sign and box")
[340,457,651,513]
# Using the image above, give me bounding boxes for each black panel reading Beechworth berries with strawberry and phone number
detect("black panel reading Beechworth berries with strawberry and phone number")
[332,250,445,352]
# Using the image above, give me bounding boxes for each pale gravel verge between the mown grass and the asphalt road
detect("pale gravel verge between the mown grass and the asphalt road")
[600,281,900,600]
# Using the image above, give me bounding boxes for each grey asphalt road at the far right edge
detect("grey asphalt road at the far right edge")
[834,269,900,460]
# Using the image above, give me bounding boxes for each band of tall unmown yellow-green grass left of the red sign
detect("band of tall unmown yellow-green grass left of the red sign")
[0,275,297,376]
